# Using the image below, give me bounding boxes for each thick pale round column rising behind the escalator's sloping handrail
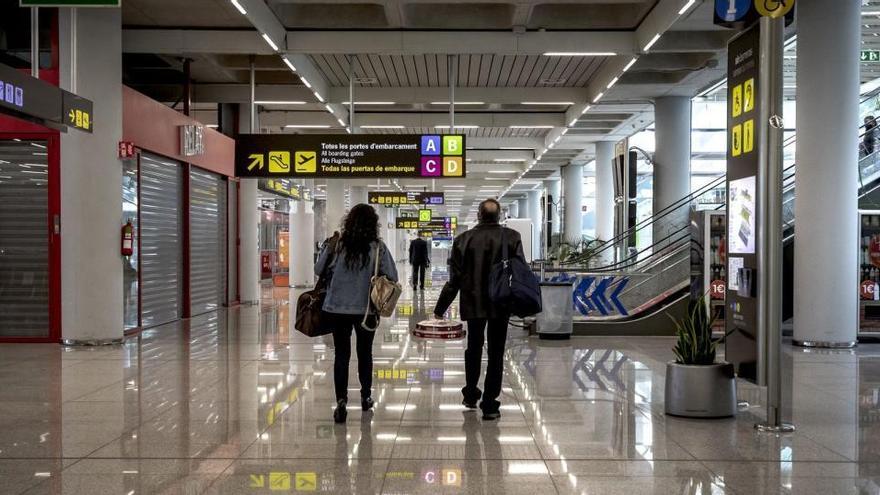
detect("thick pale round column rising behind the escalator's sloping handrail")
[654,96,691,242]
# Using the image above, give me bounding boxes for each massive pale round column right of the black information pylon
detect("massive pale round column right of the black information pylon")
[794,0,861,345]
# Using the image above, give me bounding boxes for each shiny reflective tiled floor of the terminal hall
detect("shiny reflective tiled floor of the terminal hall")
[0,270,880,495]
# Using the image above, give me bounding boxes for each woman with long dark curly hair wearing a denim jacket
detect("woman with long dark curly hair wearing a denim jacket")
[315,204,397,423]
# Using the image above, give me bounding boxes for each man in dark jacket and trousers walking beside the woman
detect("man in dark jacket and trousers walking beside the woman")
[434,199,523,420]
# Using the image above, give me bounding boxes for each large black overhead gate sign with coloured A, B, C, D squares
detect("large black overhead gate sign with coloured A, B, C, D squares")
[235,134,467,179]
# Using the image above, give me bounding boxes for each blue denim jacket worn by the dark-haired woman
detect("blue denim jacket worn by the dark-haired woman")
[315,241,397,315]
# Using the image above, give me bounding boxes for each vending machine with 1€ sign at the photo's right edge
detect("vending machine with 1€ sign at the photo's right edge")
[859,210,880,337]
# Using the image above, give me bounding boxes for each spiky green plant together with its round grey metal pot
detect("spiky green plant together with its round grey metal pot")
[665,295,736,418]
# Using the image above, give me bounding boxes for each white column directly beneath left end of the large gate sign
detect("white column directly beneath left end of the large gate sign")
[238,179,260,304]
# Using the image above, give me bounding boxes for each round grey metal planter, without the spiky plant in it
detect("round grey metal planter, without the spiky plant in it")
[666,361,736,418]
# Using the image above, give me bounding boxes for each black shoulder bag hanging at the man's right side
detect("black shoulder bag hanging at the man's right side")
[489,227,541,318]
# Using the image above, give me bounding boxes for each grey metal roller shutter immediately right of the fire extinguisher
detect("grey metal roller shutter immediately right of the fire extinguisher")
[140,153,183,327]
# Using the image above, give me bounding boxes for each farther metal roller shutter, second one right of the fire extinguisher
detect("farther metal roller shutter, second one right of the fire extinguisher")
[189,167,227,315]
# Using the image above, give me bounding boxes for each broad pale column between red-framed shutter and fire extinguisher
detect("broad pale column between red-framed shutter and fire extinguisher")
[59,9,123,344]
